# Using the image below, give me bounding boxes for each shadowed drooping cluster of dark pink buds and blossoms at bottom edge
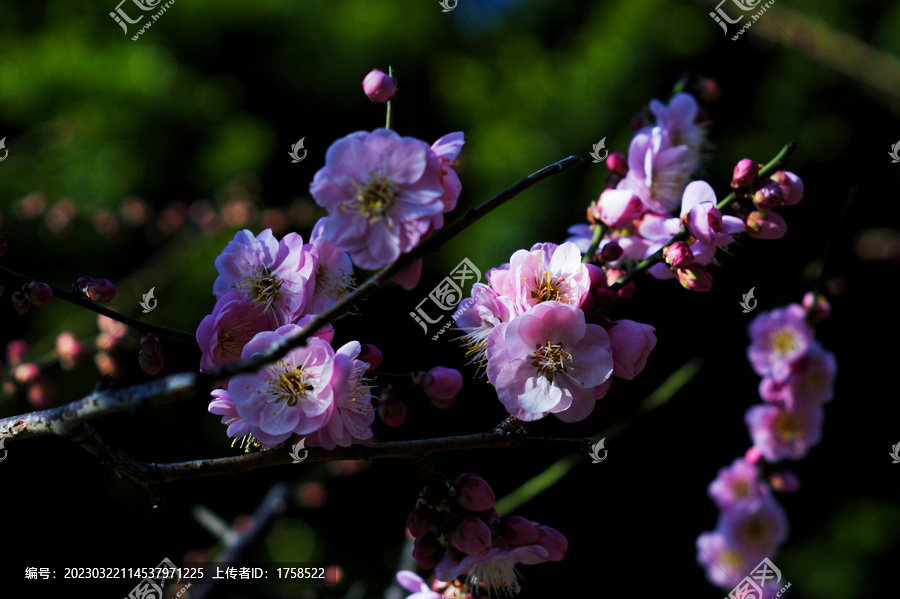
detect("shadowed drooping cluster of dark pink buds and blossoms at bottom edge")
[397,474,569,599]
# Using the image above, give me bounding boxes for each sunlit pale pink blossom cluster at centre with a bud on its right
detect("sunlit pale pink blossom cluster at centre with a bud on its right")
[456,242,656,422]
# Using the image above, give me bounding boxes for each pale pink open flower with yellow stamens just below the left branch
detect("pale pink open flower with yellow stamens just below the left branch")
[228,324,335,446]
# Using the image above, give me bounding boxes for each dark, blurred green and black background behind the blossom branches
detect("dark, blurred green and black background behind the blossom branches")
[0,0,900,599]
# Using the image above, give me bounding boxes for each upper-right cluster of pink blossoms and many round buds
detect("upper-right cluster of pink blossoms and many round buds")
[569,92,803,291]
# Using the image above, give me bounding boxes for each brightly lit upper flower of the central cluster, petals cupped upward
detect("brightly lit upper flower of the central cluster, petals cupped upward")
[509,243,591,312]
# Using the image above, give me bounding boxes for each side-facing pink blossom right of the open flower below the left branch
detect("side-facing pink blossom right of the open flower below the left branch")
[306,341,375,449]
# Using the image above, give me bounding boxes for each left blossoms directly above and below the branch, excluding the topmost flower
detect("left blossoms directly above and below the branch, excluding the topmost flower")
[197,226,374,448]
